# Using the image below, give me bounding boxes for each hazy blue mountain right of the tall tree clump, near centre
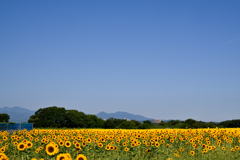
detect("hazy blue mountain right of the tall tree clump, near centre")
[96,111,154,122]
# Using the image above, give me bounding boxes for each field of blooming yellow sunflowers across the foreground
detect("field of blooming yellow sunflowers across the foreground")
[0,128,240,160]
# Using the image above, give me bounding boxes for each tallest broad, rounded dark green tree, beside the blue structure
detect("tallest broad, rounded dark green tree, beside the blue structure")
[28,106,67,127]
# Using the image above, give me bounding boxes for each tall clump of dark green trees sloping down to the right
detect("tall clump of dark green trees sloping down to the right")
[28,106,104,128]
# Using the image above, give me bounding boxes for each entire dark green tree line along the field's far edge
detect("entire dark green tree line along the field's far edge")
[0,106,240,129]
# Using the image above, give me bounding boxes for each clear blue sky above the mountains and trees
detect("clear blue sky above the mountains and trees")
[0,0,240,121]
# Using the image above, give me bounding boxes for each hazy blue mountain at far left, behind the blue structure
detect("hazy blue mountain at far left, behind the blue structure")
[0,106,35,123]
